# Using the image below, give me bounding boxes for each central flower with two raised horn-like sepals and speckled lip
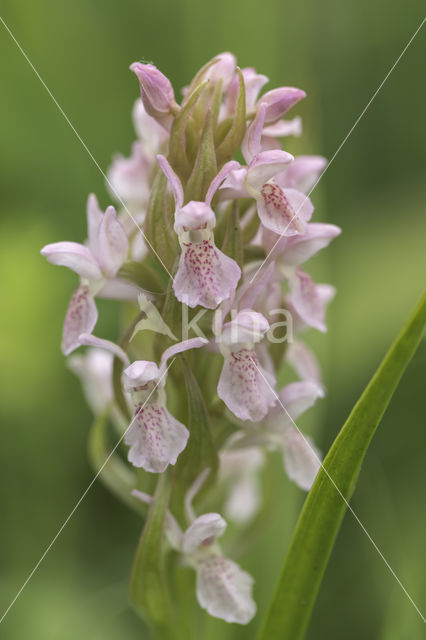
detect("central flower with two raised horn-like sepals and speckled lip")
[157,155,241,309]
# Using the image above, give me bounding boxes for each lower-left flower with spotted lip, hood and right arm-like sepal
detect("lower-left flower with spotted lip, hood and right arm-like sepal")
[123,338,207,473]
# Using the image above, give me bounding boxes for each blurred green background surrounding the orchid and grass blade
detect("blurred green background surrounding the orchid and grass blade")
[0,0,426,640]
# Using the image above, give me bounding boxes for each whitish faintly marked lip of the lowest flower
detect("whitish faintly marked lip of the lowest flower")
[197,555,256,624]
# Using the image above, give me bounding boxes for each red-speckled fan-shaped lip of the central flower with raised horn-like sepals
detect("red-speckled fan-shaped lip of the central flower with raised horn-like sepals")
[173,237,241,309]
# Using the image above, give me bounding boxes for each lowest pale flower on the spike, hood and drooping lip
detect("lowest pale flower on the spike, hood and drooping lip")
[132,478,256,624]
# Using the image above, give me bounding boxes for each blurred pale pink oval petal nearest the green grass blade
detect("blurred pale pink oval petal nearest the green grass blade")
[284,427,322,491]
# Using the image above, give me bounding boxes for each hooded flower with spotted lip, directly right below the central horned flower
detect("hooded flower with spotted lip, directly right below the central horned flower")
[217,310,276,422]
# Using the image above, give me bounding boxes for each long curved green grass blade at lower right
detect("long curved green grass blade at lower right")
[258,295,426,640]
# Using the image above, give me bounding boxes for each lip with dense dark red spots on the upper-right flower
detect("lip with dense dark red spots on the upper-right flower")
[257,182,314,236]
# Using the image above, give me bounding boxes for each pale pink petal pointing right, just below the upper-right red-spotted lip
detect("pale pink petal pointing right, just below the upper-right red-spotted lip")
[262,222,341,267]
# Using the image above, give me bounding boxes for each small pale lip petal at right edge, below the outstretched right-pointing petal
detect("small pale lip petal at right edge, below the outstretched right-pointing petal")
[288,269,335,333]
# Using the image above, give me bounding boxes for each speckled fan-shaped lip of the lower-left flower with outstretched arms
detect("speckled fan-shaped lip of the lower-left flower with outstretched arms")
[124,402,189,473]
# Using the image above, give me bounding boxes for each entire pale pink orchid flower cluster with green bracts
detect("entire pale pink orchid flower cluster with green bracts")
[42,53,340,624]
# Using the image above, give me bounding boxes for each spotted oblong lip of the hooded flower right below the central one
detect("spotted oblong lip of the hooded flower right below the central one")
[217,349,277,422]
